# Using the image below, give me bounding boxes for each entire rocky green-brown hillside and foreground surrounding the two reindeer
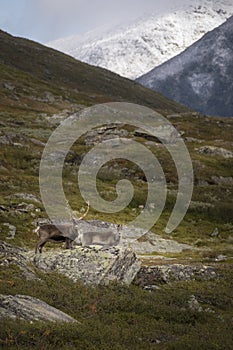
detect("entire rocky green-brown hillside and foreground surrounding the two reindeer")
[0,28,233,350]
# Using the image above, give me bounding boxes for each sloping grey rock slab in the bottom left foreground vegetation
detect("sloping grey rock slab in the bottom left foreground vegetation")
[0,294,78,322]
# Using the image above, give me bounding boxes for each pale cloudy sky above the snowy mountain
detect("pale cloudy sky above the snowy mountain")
[0,0,195,43]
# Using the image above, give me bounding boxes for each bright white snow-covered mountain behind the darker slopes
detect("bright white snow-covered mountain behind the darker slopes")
[47,0,233,79]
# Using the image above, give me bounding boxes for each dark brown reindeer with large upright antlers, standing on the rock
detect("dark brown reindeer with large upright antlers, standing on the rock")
[35,202,90,253]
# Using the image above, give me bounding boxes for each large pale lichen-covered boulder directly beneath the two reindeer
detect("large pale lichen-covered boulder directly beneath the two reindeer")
[31,246,140,285]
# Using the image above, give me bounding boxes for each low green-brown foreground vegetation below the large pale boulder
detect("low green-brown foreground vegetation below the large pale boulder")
[0,265,233,350]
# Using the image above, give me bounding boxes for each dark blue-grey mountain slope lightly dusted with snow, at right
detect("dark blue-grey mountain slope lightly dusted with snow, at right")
[138,16,233,116]
